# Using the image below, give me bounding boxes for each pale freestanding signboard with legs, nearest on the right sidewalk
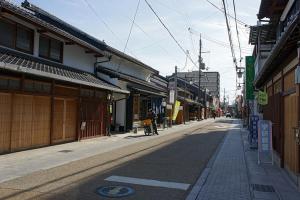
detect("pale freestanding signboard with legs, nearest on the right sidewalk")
[258,120,273,164]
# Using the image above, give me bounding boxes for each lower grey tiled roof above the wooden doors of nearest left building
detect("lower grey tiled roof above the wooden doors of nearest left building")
[0,48,129,93]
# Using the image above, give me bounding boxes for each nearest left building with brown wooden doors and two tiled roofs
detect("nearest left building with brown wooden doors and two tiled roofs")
[0,0,129,154]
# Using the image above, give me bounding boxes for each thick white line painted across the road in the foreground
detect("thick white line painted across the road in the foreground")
[105,176,190,190]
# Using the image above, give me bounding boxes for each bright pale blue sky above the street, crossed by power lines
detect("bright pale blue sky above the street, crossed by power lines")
[10,0,260,100]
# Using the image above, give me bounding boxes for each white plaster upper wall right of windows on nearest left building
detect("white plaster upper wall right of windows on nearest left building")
[63,45,96,73]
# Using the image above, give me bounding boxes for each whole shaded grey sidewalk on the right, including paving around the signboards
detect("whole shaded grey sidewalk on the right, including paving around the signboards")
[186,120,300,200]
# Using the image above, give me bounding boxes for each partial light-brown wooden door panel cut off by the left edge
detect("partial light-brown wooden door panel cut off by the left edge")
[0,93,12,153]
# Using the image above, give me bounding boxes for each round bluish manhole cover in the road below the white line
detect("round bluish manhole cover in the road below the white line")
[97,186,134,198]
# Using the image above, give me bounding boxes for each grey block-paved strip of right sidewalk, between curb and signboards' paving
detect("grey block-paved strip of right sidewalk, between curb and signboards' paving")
[187,120,251,200]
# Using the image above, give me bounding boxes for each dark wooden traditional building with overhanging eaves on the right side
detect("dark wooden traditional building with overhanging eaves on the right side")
[249,0,300,186]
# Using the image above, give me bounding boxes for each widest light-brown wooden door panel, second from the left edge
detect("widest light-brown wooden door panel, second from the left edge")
[11,94,51,151]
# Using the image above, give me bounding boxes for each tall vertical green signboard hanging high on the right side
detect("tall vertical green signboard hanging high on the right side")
[246,56,255,100]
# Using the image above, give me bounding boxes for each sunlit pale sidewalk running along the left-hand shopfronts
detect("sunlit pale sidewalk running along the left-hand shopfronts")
[0,119,214,183]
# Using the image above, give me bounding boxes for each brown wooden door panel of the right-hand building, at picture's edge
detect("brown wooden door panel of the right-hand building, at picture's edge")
[284,93,299,173]
